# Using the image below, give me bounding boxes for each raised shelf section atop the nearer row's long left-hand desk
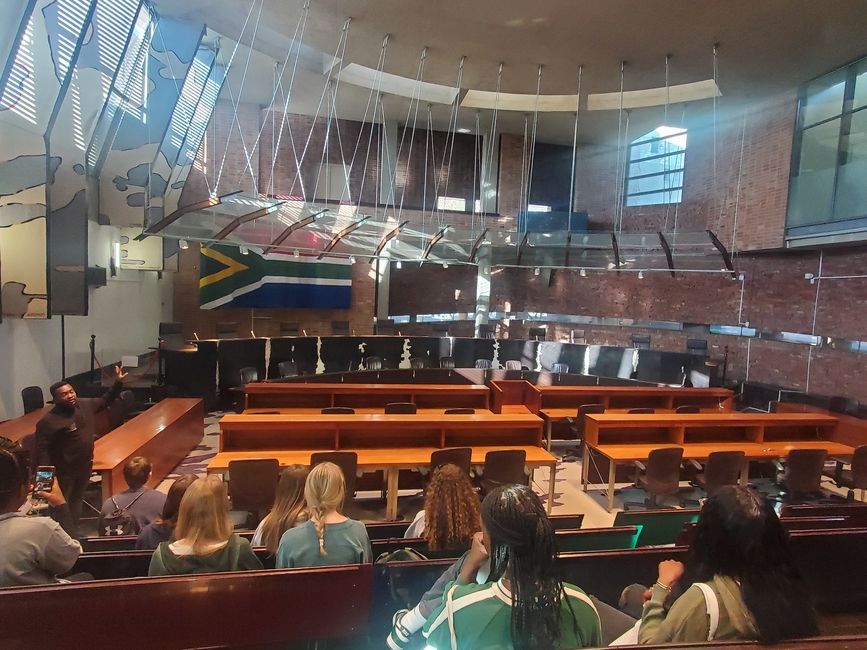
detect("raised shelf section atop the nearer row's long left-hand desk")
[220,412,542,451]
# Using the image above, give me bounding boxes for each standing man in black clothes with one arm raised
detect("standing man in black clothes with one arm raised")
[36,365,126,526]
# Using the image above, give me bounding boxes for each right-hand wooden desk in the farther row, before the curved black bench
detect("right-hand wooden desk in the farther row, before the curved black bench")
[527,386,733,413]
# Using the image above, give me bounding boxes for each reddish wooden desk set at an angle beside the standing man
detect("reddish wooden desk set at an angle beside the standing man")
[93,398,205,500]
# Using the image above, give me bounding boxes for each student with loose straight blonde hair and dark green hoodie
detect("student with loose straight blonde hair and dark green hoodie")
[148,475,262,576]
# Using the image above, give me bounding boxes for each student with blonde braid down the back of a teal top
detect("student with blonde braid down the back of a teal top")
[277,463,372,569]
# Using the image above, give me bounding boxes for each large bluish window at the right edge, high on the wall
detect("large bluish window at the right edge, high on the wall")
[786,59,867,244]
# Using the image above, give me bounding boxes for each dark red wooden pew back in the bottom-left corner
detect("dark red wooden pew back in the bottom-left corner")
[0,565,373,650]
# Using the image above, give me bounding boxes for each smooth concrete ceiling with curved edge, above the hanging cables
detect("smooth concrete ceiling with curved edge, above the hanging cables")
[156,0,867,143]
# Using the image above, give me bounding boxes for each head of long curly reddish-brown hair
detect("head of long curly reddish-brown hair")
[424,463,481,551]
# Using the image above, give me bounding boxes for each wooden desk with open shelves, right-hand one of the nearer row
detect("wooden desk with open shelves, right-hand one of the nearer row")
[581,413,853,510]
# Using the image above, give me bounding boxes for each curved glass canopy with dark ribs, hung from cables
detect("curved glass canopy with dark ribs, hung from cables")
[144,192,733,272]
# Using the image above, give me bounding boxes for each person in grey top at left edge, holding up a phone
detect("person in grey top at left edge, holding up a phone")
[0,438,81,587]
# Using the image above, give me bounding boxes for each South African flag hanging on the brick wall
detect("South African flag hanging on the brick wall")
[199,245,352,309]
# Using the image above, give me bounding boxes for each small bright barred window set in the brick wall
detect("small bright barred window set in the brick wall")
[626,126,686,206]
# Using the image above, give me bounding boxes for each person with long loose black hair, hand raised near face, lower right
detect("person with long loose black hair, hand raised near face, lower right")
[638,486,818,644]
